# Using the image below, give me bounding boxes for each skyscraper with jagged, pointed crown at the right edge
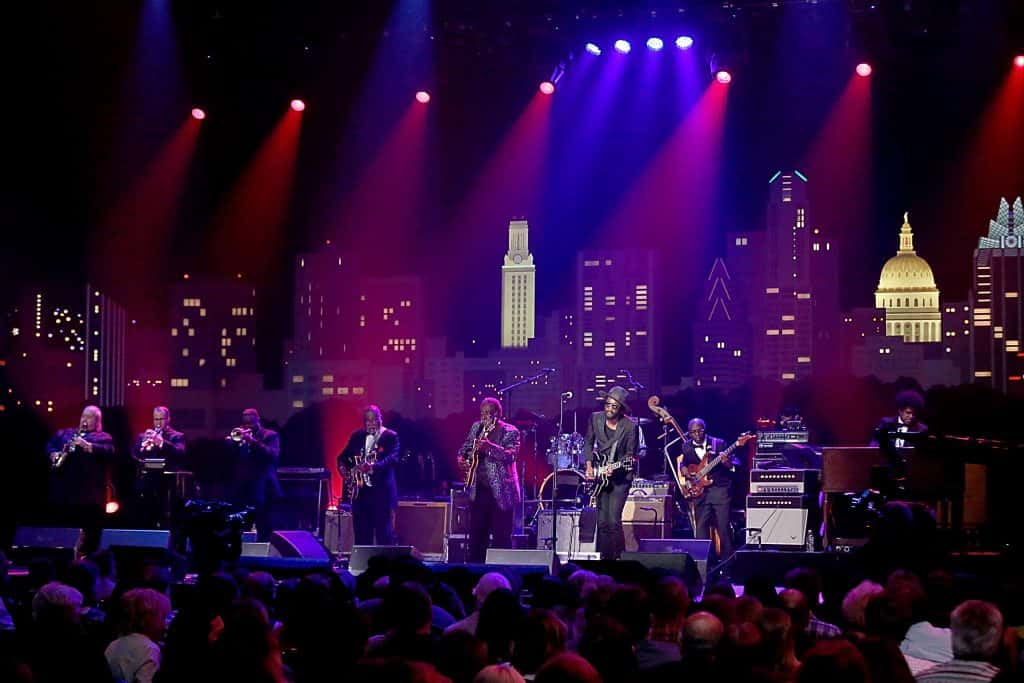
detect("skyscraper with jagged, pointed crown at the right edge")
[971,197,1024,395]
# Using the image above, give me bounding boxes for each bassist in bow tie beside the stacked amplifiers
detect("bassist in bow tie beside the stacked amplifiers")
[676,418,741,561]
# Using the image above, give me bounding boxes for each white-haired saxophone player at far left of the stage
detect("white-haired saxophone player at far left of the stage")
[46,405,114,555]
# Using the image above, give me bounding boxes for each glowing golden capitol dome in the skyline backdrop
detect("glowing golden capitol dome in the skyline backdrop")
[874,213,942,343]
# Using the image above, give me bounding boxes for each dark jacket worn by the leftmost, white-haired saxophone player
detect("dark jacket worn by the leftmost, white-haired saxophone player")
[46,429,114,505]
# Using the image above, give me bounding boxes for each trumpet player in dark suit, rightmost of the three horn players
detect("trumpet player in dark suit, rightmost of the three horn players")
[224,408,282,542]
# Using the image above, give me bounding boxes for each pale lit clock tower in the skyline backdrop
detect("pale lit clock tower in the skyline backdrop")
[502,220,537,348]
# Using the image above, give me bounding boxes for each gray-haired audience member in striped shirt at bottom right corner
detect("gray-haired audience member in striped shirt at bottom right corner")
[916,600,1004,683]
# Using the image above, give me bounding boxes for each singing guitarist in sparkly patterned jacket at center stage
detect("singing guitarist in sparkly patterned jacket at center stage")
[459,398,522,562]
